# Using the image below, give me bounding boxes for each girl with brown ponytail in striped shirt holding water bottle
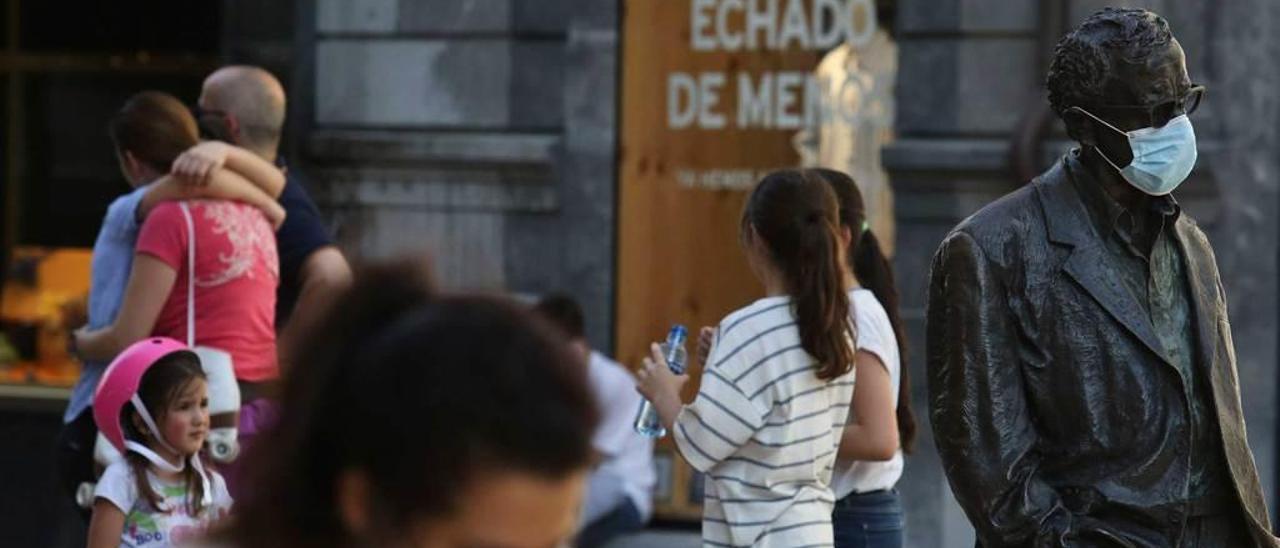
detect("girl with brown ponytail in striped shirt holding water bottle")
[639,170,854,548]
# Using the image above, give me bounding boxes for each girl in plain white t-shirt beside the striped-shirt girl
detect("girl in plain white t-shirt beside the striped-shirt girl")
[812,169,916,548]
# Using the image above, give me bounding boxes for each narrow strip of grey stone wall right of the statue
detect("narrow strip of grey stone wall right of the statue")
[1198,0,1280,520]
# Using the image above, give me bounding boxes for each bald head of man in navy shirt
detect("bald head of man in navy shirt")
[200,65,284,160]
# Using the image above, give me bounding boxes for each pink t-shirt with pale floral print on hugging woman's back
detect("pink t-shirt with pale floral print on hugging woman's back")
[137,200,280,382]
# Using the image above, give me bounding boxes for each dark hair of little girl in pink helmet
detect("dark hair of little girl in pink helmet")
[120,352,205,516]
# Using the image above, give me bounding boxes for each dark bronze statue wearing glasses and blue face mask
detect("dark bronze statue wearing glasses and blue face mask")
[928,9,1277,548]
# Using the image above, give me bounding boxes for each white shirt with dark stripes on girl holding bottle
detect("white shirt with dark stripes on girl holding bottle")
[673,297,854,548]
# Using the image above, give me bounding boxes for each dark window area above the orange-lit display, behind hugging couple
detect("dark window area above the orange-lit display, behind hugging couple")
[0,0,223,245]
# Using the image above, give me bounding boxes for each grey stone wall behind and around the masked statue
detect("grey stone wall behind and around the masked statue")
[884,0,1280,547]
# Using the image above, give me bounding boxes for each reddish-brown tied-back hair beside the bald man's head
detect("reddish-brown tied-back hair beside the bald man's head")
[109,91,200,173]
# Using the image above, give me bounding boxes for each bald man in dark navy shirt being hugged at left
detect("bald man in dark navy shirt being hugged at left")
[198,65,351,371]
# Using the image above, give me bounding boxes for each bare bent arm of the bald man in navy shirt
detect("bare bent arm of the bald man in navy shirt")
[278,246,351,373]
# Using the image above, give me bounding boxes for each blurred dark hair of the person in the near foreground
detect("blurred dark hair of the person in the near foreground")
[227,257,596,548]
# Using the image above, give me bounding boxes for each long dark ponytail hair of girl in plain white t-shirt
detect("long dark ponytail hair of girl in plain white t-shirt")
[813,168,918,453]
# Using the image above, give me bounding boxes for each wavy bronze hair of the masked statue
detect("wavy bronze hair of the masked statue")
[1044,8,1174,117]
